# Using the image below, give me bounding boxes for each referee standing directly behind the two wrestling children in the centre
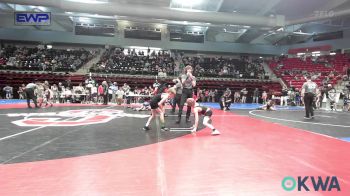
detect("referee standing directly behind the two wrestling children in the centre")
[176,65,196,124]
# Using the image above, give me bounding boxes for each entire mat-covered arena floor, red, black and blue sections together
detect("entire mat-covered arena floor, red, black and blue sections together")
[0,101,350,196]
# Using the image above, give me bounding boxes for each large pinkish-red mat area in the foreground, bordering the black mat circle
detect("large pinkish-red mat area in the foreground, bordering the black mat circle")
[0,110,350,196]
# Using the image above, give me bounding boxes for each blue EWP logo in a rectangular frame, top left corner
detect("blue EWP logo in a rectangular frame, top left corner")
[15,12,51,25]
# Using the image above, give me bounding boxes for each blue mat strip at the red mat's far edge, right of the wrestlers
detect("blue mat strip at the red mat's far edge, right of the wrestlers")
[199,103,304,110]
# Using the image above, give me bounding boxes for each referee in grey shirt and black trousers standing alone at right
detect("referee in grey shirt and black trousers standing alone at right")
[301,76,317,119]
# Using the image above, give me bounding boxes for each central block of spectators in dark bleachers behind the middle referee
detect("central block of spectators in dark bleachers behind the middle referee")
[90,48,265,79]
